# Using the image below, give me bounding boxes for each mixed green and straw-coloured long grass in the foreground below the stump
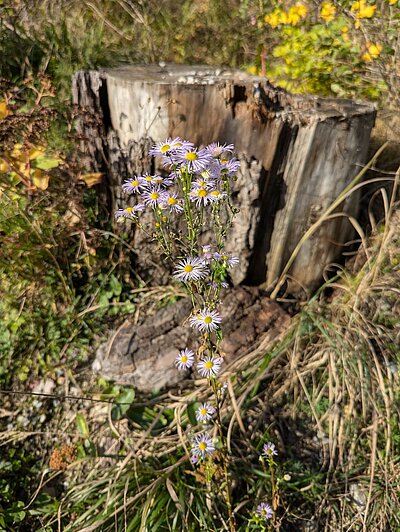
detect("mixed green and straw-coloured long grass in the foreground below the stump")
[13,189,400,531]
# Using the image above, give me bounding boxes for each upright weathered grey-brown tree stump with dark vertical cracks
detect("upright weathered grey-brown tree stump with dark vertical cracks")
[73,65,375,292]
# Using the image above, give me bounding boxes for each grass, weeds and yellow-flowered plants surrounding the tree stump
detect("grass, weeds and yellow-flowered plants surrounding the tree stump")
[0,0,400,531]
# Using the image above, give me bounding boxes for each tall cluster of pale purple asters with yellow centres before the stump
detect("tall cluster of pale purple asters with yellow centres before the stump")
[115,137,240,512]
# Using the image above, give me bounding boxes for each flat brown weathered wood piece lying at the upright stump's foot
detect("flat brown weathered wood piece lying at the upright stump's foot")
[93,287,289,392]
